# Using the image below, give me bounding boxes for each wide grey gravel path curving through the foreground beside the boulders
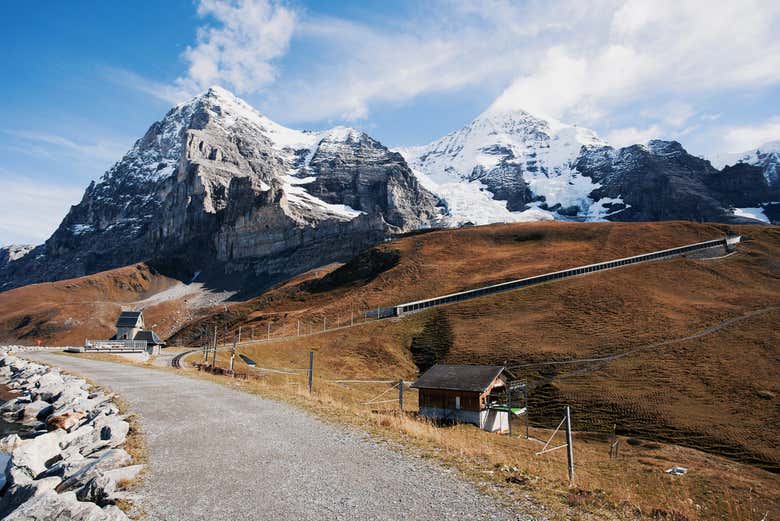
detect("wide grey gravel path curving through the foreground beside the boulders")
[28,353,530,520]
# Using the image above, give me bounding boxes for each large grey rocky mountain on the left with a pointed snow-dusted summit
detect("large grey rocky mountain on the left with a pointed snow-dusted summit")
[0,87,441,289]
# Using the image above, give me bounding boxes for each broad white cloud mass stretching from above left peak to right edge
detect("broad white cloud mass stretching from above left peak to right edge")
[112,0,780,150]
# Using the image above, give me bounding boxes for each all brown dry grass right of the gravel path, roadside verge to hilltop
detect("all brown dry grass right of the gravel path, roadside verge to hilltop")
[7,218,780,519]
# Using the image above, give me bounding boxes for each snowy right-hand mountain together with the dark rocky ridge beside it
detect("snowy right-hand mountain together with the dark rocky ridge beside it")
[399,110,780,225]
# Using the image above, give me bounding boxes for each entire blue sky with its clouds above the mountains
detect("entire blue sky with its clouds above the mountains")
[0,0,780,244]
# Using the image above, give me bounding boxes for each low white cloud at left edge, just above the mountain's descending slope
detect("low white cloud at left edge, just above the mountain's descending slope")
[0,171,84,245]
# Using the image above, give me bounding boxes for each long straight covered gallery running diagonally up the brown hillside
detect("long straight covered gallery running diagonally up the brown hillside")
[394,236,741,316]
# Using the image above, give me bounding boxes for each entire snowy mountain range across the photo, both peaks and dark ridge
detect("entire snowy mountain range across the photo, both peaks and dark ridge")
[0,87,780,289]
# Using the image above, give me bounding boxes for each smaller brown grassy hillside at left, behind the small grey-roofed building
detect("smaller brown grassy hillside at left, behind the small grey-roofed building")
[0,264,186,345]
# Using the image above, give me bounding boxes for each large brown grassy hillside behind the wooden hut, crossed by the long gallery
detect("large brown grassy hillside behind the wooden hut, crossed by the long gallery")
[176,222,780,472]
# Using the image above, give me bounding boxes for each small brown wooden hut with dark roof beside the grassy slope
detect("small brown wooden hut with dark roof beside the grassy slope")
[412,364,525,432]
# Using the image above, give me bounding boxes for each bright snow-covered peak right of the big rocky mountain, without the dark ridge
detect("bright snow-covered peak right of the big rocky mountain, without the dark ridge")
[398,108,606,224]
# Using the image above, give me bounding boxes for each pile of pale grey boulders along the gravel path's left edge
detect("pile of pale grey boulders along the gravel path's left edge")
[0,348,142,521]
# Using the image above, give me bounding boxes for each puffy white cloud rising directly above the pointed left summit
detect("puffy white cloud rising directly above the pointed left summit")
[176,0,296,93]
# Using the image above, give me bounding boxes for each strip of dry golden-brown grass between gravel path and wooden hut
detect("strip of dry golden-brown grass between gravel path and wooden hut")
[188,346,780,520]
